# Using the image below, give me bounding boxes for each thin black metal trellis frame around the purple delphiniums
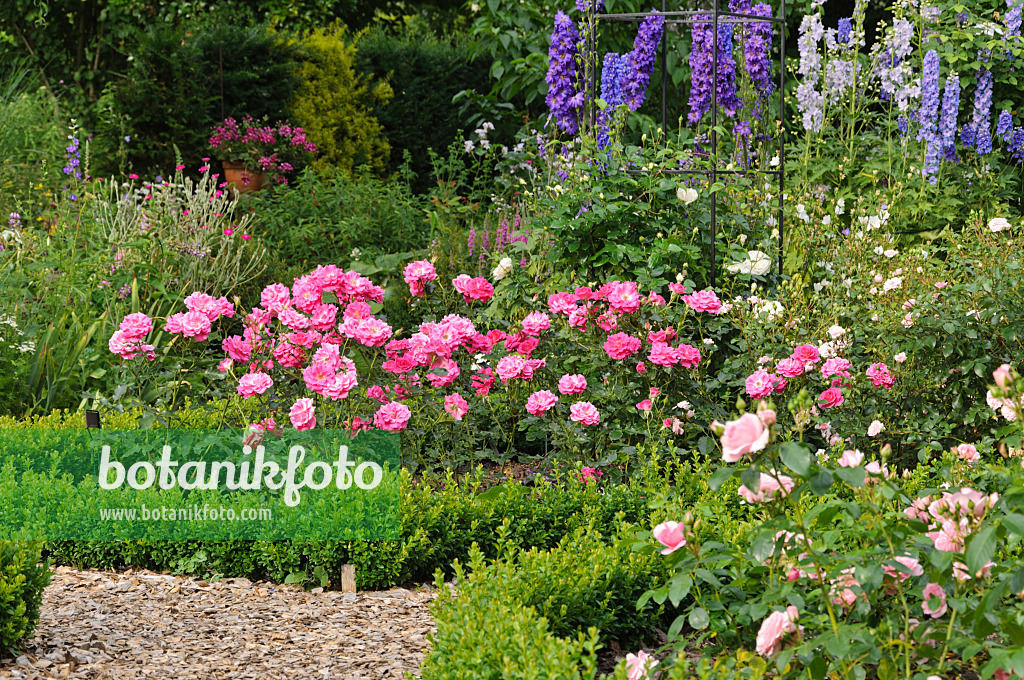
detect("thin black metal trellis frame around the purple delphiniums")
[586,0,785,287]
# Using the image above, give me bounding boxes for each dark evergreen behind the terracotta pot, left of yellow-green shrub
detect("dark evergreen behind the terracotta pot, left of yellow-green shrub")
[114,23,299,173]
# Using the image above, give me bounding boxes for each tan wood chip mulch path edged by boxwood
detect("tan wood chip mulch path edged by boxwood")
[0,566,434,680]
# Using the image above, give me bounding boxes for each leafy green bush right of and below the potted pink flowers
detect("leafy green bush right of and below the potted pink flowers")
[251,170,429,270]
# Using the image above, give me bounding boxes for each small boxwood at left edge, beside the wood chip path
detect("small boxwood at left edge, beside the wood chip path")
[0,541,50,653]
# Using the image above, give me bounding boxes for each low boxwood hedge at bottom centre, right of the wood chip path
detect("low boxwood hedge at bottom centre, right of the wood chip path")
[422,526,664,678]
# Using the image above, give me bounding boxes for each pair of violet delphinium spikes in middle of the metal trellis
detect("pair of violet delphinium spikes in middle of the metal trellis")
[687,14,742,123]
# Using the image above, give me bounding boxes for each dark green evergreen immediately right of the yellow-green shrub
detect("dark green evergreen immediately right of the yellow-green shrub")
[356,30,490,194]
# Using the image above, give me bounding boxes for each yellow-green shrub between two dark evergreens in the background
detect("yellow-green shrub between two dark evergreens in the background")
[291,26,392,175]
